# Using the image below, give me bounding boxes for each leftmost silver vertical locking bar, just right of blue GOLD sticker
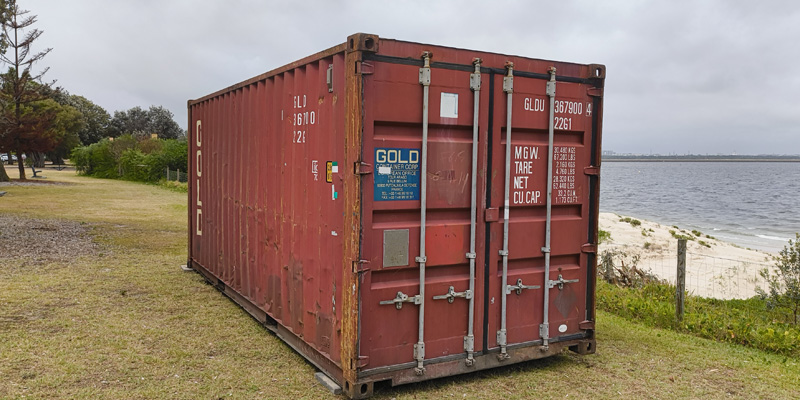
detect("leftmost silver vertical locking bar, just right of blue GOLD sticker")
[414,51,432,376]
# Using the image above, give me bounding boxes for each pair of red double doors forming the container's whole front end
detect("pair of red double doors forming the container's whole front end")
[356,57,596,373]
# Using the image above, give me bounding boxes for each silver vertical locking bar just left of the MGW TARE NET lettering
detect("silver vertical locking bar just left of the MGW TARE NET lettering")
[497,61,514,361]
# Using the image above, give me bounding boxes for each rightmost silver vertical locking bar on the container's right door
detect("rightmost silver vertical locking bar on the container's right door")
[539,67,556,351]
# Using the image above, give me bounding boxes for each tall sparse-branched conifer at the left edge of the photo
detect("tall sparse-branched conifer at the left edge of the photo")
[0,0,52,179]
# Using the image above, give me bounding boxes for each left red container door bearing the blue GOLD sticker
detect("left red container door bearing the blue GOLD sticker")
[360,54,488,369]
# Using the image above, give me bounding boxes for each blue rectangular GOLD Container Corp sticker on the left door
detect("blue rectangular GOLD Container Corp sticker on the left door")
[374,148,420,201]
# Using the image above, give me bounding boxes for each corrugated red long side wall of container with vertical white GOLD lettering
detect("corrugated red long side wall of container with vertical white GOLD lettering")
[190,54,349,368]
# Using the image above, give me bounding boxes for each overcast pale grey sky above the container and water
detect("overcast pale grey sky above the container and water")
[25,0,800,154]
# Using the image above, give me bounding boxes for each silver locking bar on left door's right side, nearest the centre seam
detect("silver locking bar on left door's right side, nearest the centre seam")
[462,58,481,367]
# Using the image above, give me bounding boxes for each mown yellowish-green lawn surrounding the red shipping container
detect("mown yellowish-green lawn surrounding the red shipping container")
[0,170,800,399]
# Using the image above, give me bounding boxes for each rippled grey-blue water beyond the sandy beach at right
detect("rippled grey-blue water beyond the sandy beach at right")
[600,162,800,253]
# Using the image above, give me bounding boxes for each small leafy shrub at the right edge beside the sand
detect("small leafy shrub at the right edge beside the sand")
[756,233,800,325]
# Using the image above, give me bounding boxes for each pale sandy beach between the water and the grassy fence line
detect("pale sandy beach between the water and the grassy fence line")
[599,213,773,299]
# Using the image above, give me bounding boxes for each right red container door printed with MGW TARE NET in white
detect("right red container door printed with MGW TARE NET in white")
[486,67,596,359]
